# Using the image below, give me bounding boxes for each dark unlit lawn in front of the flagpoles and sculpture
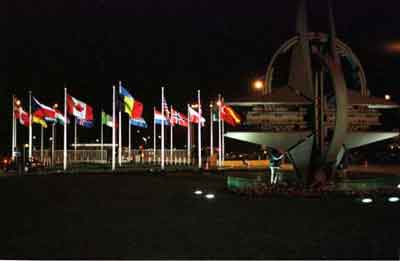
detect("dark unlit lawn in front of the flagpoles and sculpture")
[0,172,400,259]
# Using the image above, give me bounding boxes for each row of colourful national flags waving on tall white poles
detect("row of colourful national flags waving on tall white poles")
[14,86,241,132]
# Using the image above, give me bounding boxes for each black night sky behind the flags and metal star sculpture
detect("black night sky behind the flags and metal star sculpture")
[0,0,400,152]
